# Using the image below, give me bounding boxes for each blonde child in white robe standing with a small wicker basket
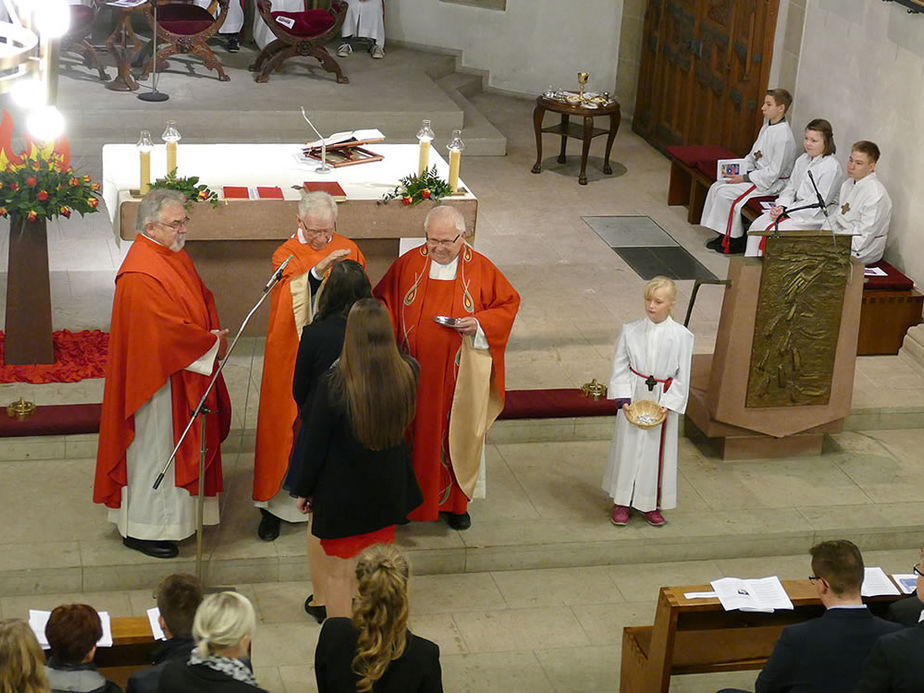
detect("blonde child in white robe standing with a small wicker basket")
[603,277,693,527]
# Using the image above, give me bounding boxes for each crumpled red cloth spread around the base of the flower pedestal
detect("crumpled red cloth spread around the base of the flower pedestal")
[0,330,109,384]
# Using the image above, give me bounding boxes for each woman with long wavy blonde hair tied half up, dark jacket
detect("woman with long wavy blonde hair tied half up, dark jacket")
[314,544,443,693]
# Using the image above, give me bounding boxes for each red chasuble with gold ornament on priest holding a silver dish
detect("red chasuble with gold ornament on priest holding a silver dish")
[373,245,520,521]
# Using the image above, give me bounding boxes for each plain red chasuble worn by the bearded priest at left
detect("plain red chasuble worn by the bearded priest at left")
[93,234,231,508]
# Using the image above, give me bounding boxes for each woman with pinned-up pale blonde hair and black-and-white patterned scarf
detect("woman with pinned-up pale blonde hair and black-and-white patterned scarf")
[158,592,266,693]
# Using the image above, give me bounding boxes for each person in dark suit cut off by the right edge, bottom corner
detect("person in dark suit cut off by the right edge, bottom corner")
[854,548,924,693]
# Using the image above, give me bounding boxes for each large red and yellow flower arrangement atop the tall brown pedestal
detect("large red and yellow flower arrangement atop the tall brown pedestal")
[0,110,100,221]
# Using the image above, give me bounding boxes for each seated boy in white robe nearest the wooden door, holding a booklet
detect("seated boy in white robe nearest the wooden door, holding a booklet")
[700,89,796,255]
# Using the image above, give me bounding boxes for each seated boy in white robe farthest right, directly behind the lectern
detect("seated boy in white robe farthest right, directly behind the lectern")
[831,140,892,265]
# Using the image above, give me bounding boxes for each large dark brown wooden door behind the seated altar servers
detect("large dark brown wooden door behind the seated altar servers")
[632,0,779,155]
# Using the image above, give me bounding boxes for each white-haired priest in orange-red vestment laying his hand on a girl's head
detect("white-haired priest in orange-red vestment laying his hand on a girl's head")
[253,192,366,541]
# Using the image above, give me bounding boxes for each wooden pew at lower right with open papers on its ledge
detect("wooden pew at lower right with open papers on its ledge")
[619,580,900,693]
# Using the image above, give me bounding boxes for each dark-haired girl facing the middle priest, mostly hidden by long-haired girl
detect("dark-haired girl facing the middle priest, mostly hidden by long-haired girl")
[283,260,372,623]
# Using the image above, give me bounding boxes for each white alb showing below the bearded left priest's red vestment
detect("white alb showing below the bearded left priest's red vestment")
[109,339,219,541]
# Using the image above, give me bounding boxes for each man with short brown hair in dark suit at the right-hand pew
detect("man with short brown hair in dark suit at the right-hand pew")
[723,539,901,693]
